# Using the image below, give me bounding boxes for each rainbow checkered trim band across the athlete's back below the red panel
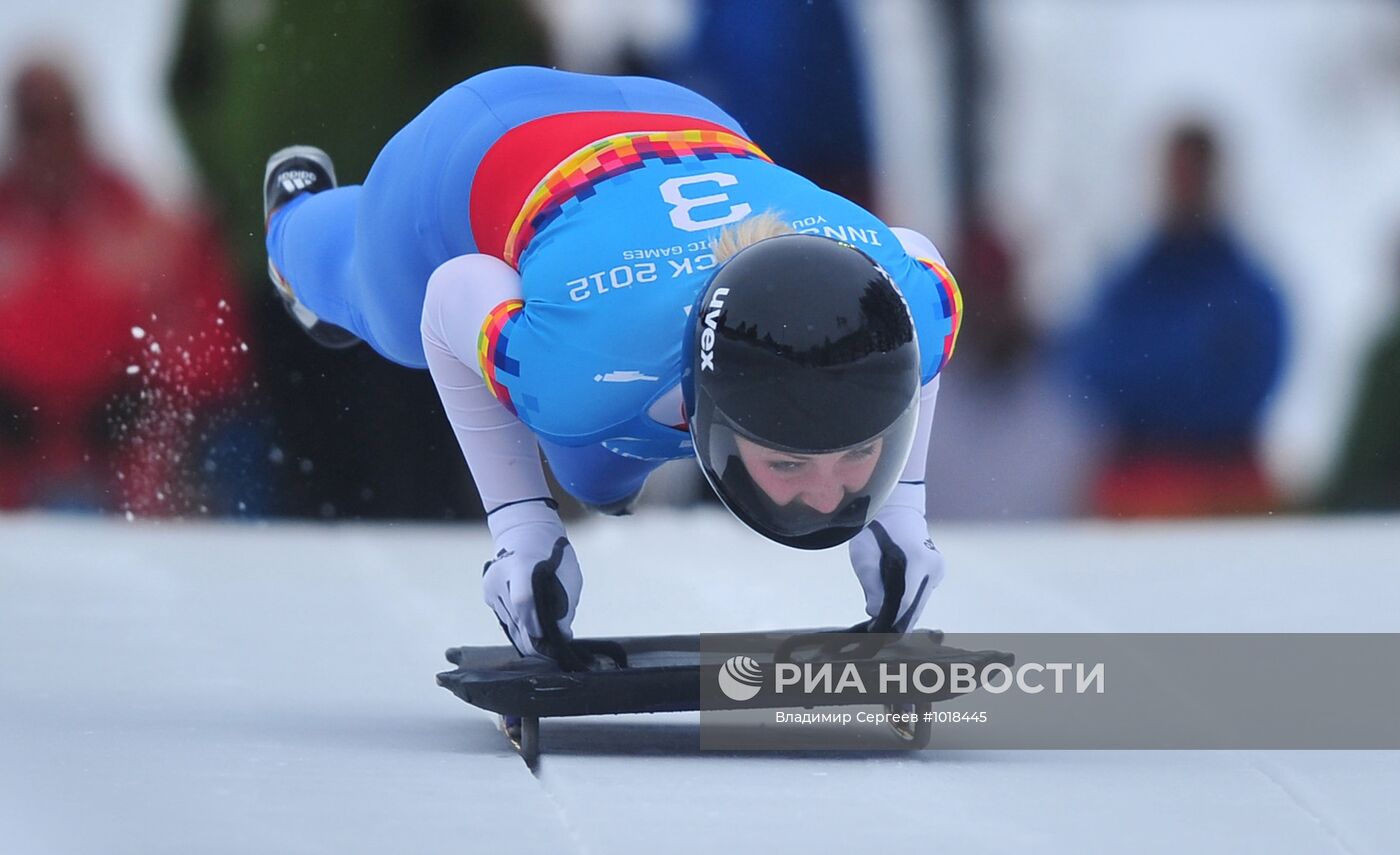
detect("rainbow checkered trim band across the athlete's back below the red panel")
[504,130,773,267]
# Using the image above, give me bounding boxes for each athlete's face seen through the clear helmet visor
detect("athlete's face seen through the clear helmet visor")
[735,437,885,514]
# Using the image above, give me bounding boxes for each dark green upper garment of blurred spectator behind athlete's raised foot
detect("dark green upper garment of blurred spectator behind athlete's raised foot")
[171,0,546,281]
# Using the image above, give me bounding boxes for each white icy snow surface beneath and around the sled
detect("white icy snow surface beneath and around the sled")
[0,511,1400,855]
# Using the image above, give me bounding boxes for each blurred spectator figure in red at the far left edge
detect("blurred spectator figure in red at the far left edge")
[0,62,246,514]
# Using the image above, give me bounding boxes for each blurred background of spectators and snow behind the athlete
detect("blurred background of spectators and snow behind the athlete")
[0,0,1400,521]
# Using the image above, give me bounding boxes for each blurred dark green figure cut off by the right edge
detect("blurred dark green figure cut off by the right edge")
[1323,237,1400,511]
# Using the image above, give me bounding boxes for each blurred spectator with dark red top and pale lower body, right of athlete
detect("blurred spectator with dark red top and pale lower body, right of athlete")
[928,214,1093,521]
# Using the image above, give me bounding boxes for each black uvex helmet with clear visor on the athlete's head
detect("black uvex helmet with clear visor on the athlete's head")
[683,235,920,549]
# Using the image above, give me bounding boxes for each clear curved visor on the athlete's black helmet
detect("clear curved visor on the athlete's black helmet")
[694,393,918,549]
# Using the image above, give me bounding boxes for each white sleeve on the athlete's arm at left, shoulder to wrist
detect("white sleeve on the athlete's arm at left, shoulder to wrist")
[421,253,553,535]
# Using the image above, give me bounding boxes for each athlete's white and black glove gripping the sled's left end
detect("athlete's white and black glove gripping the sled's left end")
[482,501,584,667]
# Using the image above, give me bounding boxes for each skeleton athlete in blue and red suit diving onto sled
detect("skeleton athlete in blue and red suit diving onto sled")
[265,67,960,662]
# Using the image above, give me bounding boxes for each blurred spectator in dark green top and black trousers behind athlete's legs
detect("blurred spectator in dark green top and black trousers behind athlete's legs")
[171,0,549,519]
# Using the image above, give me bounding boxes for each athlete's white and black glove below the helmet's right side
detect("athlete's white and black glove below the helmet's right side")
[850,484,944,633]
